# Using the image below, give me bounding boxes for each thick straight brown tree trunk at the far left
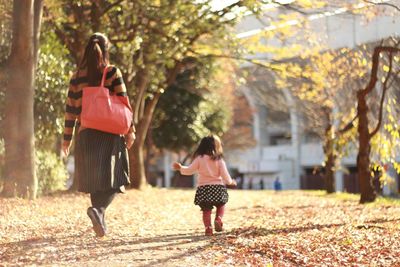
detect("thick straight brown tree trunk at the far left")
[3,0,37,199]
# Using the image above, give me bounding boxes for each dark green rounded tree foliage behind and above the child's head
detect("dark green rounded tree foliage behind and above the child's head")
[152,60,231,152]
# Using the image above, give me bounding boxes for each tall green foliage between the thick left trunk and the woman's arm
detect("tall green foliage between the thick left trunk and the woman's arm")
[34,31,72,149]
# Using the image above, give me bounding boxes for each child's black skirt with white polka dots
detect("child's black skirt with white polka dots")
[194,184,229,205]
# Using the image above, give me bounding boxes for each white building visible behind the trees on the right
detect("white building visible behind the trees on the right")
[227,1,400,195]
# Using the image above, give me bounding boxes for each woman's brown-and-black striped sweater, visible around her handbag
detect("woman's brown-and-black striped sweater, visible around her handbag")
[64,65,134,148]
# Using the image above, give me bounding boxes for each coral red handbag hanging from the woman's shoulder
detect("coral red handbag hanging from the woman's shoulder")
[81,66,133,134]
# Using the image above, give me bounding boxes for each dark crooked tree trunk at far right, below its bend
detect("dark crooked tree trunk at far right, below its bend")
[357,91,376,203]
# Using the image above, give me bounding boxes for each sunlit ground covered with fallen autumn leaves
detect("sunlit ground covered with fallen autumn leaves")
[0,189,400,266]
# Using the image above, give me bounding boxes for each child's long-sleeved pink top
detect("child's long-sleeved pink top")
[181,155,232,186]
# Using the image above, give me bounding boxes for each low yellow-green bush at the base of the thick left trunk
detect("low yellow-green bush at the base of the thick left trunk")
[36,150,68,196]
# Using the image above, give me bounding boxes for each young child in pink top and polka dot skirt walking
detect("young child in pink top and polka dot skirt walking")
[172,135,236,236]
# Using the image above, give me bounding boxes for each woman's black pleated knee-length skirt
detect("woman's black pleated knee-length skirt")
[75,129,130,193]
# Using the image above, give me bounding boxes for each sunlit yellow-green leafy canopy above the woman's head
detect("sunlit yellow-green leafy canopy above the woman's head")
[46,0,253,110]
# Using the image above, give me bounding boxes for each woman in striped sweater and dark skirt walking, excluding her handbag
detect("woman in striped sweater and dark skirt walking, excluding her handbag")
[62,33,135,237]
